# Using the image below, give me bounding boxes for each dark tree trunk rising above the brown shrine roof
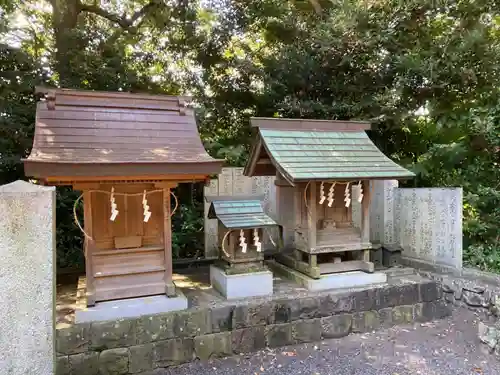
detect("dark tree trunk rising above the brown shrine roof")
[51,0,81,87]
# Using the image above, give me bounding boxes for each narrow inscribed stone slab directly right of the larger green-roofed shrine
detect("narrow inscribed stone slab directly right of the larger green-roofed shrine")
[370,180,398,245]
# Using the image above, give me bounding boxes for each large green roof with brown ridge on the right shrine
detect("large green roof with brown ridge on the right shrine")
[244,118,415,184]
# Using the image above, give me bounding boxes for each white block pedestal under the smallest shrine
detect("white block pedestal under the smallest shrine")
[210,266,273,299]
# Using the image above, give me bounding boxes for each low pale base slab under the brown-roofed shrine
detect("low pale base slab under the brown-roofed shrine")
[75,288,188,323]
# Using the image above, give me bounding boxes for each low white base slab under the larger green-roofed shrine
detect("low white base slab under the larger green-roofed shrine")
[267,260,387,292]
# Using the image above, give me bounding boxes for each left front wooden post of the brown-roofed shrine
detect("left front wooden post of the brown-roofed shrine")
[83,190,96,307]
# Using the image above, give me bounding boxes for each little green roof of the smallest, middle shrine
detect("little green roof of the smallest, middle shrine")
[208,200,277,229]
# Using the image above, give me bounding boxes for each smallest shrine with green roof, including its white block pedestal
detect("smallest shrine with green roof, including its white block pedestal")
[206,197,279,299]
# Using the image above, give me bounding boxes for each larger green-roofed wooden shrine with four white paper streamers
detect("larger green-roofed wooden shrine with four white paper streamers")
[244,118,414,278]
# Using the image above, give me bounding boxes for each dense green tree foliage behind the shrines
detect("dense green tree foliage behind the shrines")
[0,0,500,270]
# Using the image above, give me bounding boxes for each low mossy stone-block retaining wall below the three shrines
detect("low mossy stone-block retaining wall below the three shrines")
[56,281,450,375]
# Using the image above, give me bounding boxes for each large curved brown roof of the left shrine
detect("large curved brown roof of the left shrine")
[24,89,222,179]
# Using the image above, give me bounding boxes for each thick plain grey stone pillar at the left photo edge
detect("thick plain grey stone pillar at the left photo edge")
[0,181,56,375]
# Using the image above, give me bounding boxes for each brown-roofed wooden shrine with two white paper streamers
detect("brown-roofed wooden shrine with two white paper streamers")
[24,89,222,306]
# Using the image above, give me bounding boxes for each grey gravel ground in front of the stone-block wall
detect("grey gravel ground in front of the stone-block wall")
[168,309,500,375]
